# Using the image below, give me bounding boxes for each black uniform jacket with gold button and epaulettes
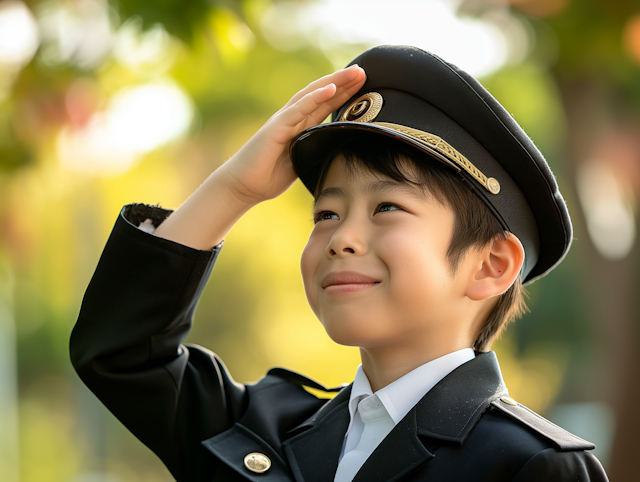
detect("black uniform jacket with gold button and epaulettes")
[71,205,607,482]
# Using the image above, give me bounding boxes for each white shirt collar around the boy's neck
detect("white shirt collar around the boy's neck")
[347,348,475,426]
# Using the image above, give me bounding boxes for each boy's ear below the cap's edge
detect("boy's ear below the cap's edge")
[466,233,524,301]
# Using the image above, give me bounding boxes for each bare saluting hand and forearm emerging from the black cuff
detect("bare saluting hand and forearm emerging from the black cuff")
[154,66,365,249]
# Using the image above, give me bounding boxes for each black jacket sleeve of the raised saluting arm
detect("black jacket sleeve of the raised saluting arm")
[70,205,247,481]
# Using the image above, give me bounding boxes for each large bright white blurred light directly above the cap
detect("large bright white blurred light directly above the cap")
[262,0,528,76]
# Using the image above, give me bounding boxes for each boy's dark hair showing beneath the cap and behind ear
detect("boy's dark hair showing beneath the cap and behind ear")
[315,134,527,351]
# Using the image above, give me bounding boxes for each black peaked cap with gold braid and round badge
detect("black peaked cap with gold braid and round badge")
[290,45,573,283]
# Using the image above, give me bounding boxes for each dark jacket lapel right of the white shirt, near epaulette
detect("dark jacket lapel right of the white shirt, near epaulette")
[352,352,508,482]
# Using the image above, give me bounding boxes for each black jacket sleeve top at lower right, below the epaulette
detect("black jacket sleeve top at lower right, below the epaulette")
[513,448,609,482]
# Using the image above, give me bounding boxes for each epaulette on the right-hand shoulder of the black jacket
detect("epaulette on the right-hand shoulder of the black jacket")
[491,397,596,451]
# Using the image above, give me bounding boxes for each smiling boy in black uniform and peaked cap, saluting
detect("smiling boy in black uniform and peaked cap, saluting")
[71,46,607,482]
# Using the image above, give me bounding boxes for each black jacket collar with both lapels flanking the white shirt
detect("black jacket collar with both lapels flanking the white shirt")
[284,352,508,482]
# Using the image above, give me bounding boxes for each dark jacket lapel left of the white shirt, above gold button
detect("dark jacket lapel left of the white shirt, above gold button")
[283,386,351,482]
